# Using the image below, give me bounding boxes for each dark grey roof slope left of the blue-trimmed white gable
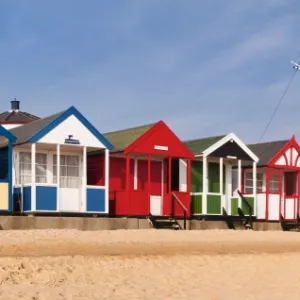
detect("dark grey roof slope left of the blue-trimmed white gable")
[9,112,63,144]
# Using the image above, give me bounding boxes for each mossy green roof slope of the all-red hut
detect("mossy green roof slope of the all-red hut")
[104,123,156,150]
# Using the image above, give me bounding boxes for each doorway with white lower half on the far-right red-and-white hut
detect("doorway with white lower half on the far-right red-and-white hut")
[281,172,298,220]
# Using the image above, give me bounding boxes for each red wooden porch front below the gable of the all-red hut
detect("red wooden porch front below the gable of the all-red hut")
[109,153,191,217]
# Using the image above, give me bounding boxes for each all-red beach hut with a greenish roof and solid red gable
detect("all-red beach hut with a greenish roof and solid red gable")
[88,121,194,217]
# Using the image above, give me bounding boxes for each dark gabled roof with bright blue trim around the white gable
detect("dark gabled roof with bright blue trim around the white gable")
[10,106,112,150]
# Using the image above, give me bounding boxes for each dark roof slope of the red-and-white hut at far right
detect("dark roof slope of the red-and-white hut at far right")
[247,140,289,166]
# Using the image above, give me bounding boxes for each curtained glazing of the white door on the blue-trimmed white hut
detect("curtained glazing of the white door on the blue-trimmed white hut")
[53,155,80,188]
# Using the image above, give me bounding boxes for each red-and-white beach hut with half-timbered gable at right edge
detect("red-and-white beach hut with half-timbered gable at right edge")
[242,136,300,221]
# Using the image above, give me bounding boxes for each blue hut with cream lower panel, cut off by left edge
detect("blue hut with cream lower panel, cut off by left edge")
[0,125,16,213]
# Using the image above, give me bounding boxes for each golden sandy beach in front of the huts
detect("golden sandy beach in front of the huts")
[0,230,300,300]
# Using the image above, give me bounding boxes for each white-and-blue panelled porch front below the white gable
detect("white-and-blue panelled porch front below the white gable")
[13,143,109,213]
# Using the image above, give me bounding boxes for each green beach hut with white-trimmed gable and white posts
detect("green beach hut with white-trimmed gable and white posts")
[185,133,258,217]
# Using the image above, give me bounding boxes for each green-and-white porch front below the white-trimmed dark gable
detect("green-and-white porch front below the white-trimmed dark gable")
[191,157,256,216]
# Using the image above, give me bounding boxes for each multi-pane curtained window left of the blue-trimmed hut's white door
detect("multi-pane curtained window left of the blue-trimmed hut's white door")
[19,152,47,184]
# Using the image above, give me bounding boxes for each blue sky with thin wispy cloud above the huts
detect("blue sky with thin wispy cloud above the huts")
[0,0,300,142]
